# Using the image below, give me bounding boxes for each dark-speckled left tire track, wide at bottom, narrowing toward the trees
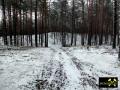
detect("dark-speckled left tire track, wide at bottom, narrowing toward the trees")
[36,51,68,90]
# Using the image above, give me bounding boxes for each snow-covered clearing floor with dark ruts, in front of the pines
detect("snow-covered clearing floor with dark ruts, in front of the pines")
[0,34,120,90]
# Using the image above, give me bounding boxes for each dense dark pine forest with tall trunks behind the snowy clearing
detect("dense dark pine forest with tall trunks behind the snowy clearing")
[0,0,120,48]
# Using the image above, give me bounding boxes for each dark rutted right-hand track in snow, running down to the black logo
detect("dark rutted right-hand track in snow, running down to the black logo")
[61,48,116,90]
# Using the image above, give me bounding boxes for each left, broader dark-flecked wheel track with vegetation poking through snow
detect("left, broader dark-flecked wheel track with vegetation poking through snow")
[24,49,69,90]
